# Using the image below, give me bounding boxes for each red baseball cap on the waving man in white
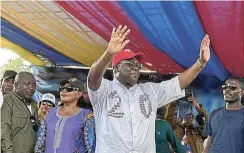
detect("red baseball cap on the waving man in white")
[112,49,145,67]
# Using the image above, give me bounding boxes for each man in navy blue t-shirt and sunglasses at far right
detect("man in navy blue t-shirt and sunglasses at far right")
[203,76,244,153]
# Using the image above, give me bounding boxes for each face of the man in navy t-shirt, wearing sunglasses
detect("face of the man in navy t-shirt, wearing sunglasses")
[222,79,243,103]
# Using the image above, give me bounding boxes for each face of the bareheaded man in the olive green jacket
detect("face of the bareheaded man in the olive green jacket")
[15,75,36,99]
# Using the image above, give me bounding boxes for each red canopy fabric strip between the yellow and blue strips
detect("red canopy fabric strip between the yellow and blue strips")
[57,1,184,74]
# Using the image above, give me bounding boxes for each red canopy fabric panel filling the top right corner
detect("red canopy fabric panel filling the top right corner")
[195,1,244,77]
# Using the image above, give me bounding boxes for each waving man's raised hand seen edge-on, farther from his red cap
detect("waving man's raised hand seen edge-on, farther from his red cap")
[200,34,210,64]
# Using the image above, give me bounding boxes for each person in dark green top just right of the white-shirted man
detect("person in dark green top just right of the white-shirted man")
[155,108,186,153]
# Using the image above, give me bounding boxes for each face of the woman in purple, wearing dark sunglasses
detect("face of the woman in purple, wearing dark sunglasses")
[60,83,82,103]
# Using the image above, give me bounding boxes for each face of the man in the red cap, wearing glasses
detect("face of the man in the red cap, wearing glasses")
[116,58,142,86]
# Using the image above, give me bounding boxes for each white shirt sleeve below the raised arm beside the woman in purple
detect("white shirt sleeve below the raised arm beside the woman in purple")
[87,78,110,107]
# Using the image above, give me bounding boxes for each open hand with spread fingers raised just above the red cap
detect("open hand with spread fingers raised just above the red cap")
[107,25,130,55]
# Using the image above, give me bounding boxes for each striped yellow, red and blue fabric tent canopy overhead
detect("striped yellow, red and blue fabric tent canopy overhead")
[1,1,244,81]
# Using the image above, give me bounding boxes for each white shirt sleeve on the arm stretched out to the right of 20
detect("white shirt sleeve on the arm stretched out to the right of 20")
[151,76,185,107]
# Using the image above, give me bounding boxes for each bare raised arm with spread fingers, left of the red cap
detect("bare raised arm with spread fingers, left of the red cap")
[88,25,130,91]
